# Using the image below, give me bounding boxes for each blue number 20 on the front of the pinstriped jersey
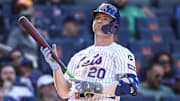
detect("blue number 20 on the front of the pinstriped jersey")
[88,67,106,79]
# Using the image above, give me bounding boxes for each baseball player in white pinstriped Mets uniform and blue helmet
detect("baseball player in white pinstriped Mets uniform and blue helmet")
[41,3,138,101]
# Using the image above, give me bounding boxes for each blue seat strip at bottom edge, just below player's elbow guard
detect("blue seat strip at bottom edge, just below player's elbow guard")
[120,96,155,101]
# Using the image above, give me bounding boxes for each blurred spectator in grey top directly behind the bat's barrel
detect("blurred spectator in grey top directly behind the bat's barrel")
[7,10,49,56]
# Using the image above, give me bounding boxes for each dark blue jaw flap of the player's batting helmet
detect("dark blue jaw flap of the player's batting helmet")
[101,21,118,34]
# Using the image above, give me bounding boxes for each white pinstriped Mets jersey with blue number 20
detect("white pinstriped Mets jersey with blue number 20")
[64,42,136,101]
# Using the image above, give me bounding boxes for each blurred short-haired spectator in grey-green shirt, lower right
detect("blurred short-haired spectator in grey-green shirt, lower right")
[138,64,174,101]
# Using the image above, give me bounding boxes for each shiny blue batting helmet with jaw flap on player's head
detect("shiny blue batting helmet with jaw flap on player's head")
[93,3,120,34]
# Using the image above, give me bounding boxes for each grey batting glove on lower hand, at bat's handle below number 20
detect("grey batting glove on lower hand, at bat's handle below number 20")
[70,78,103,93]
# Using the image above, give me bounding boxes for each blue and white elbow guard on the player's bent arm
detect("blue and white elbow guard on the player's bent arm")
[115,74,138,96]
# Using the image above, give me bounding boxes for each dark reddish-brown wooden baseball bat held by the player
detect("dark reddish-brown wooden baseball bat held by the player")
[18,16,74,78]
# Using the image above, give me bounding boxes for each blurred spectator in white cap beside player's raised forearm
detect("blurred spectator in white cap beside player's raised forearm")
[37,75,63,101]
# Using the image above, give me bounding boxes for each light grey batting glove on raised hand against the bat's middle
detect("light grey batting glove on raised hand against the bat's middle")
[40,44,60,71]
